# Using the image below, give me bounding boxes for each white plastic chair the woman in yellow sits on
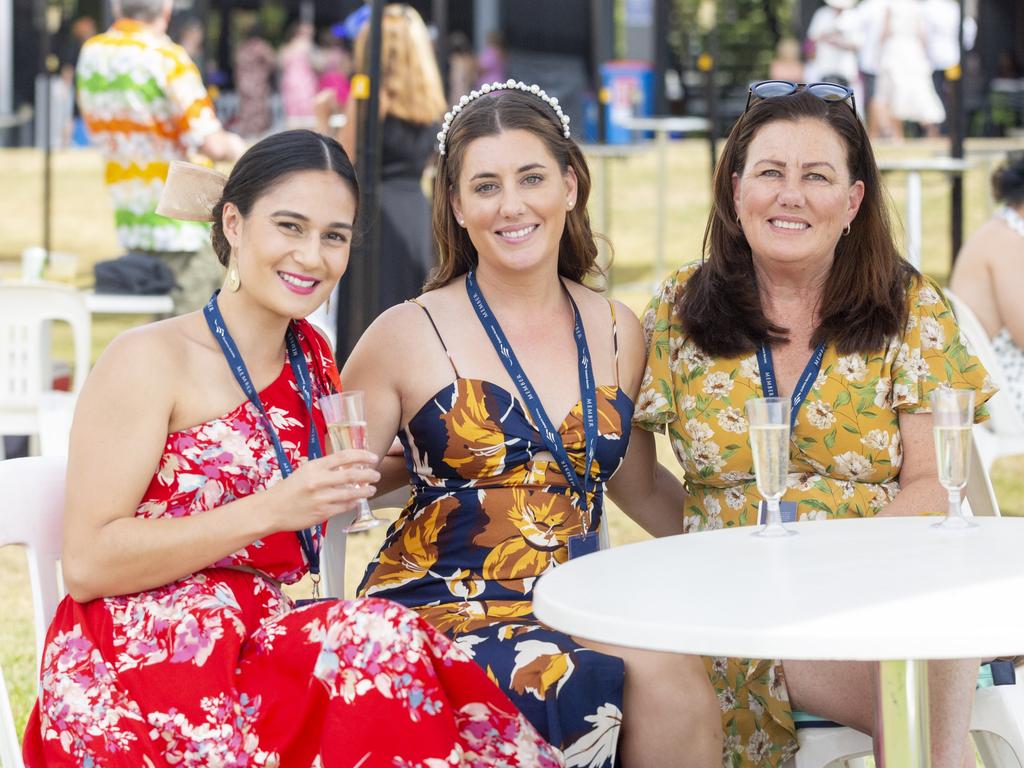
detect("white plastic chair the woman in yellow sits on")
[794,438,1024,768]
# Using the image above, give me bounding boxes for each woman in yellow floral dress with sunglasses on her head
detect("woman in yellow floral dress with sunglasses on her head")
[634,81,994,768]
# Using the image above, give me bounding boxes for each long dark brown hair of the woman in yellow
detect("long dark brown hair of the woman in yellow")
[676,91,918,357]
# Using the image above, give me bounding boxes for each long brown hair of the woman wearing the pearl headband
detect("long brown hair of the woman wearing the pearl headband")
[424,89,599,291]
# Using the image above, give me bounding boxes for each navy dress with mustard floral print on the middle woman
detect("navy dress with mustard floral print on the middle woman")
[359,378,633,768]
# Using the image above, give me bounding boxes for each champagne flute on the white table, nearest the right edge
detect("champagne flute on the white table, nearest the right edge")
[931,389,978,529]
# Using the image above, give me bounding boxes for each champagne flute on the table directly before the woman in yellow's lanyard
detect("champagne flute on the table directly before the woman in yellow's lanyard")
[746,397,797,538]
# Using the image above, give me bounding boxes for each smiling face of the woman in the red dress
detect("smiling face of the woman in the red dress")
[223,171,356,317]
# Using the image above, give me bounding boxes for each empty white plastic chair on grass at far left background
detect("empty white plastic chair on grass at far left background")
[0,282,92,458]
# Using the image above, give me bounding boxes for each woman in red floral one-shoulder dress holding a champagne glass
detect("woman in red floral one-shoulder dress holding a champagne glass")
[25,131,561,768]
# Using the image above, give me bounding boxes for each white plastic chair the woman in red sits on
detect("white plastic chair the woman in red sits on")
[0,456,67,768]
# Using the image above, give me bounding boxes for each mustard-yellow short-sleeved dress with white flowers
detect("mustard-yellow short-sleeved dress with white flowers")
[634,262,995,768]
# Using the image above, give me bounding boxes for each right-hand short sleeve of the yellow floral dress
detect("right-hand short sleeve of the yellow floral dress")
[892,278,996,423]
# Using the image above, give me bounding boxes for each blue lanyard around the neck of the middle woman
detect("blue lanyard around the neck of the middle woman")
[466,270,598,535]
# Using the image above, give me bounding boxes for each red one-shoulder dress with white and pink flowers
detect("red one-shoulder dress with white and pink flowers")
[24,323,561,768]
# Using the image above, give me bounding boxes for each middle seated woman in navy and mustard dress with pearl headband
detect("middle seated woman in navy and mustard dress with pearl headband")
[343,81,722,768]
